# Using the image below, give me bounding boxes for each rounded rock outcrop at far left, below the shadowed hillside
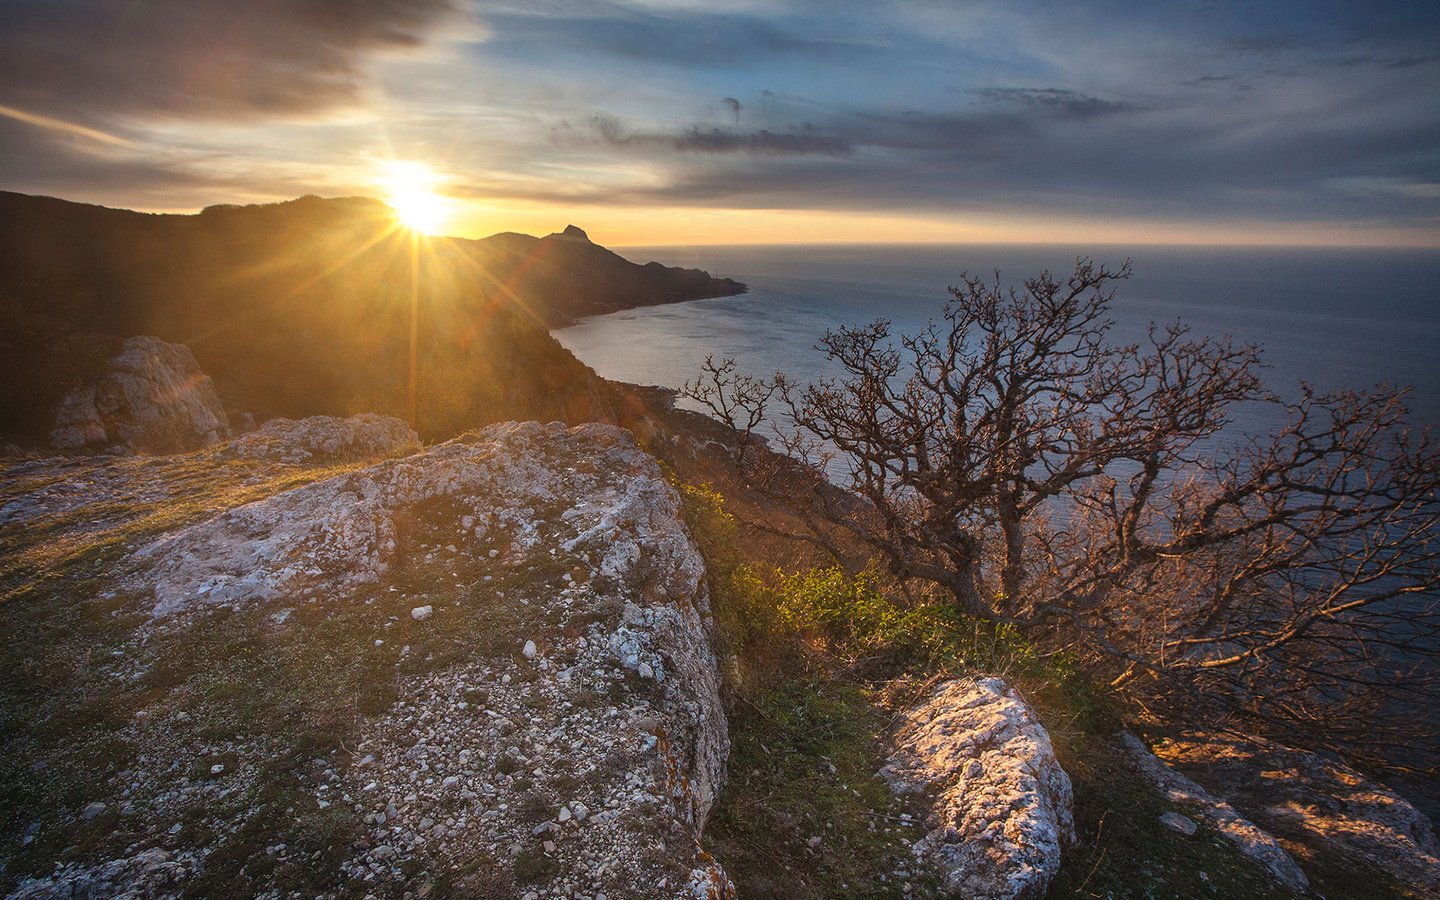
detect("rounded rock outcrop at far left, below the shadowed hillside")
[50,336,230,454]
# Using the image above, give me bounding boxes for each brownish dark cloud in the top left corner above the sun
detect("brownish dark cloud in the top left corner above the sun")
[0,0,454,120]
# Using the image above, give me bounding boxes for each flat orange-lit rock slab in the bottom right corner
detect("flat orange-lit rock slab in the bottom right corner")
[1156,733,1440,896]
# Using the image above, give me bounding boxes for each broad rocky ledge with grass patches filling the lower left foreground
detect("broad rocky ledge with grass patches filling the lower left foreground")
[0,420,730,897]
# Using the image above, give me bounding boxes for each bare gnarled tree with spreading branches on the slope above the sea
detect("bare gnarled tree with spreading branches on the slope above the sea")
[690,261,1440,766]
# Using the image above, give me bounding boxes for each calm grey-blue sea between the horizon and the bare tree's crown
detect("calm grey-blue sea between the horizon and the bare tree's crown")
[556,245,1440,431]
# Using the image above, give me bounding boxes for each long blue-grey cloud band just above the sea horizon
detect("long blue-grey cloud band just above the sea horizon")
[524,78,1440,231]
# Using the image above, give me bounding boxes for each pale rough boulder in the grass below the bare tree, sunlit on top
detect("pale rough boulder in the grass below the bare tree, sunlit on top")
[881,678,1076,899]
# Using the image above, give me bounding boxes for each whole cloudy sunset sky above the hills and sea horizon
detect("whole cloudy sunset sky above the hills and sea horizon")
[0,0,1440,246]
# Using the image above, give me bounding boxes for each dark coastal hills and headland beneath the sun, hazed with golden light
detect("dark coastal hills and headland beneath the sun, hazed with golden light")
[0,193,742,441]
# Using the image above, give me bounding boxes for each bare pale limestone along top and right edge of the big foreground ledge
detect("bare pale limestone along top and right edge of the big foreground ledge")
[115,422,733,897]
